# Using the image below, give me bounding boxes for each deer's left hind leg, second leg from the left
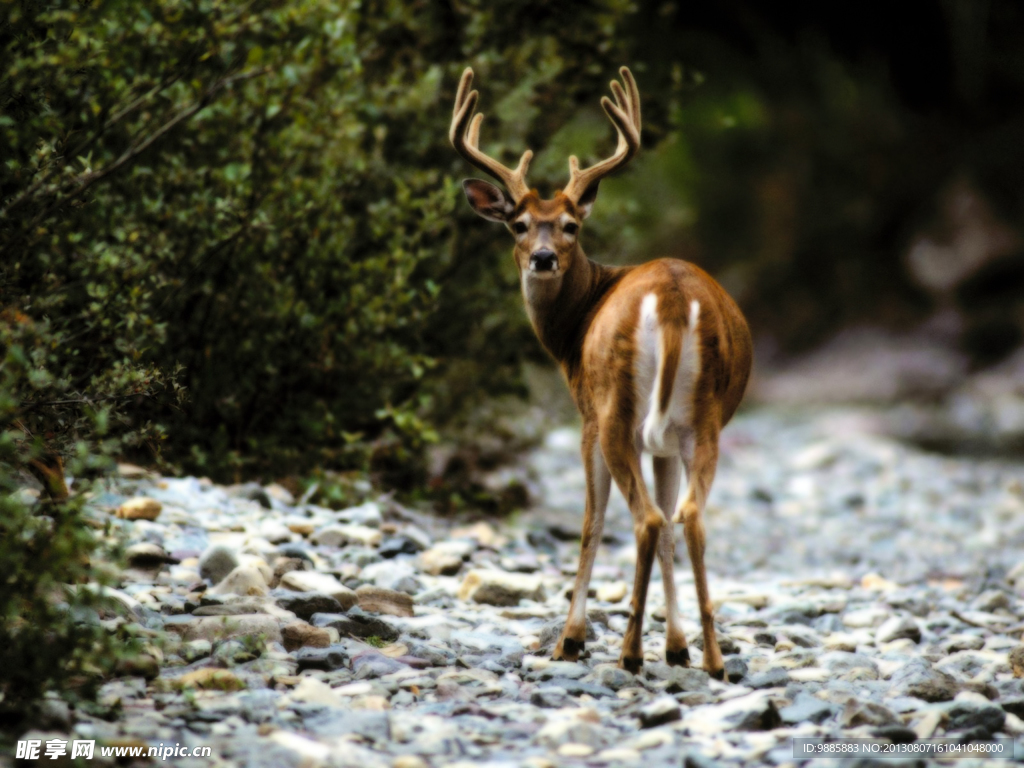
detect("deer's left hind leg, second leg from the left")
[600,419,669,673]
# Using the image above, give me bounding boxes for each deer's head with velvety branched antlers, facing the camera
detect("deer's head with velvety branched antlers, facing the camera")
[449,67,640,280]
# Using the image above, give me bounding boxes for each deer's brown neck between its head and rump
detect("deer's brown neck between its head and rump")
[520,245,622,370]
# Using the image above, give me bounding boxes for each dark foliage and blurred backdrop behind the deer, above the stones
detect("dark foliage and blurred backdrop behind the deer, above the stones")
[0,0,1024,509]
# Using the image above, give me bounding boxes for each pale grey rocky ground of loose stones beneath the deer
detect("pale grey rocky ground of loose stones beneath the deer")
[8,409,1024,768]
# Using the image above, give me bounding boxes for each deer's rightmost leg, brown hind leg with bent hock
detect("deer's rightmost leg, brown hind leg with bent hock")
[673,424,725,680]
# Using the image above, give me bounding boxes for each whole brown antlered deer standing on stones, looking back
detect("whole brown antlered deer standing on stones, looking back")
[449,67,752,680]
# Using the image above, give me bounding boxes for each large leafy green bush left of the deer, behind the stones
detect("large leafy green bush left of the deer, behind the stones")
[0,0,629,482]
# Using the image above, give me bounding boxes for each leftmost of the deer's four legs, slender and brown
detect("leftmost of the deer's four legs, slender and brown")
[552,424,611,662]
